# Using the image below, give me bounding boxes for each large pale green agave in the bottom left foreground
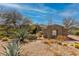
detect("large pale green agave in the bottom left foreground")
[3,41,21,56]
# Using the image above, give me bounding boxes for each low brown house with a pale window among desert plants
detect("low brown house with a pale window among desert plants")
[43,24,67,38]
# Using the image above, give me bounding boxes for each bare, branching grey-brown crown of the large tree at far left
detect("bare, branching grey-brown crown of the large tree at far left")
[1,9,22,28]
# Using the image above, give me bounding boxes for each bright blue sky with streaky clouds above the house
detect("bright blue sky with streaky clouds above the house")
[0,3,79,24]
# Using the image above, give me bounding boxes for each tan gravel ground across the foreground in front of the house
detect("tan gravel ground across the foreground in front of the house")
[0,40,79,56]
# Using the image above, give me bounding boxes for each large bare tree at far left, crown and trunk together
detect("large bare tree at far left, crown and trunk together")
[0,9,22,36]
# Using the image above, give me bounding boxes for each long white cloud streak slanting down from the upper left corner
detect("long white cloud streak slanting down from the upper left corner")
[0,3,45,13]
